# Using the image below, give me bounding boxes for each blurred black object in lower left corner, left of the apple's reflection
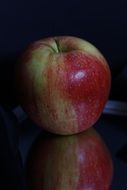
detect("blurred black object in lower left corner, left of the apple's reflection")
[0,106,26,190]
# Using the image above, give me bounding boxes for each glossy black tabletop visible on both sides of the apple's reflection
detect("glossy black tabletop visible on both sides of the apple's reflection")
[19,115,127,190]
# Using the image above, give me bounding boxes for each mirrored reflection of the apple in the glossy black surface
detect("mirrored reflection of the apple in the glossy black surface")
[26,127,113,190]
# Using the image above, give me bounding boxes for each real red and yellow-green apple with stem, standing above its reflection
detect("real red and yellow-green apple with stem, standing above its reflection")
[16,36,111,135]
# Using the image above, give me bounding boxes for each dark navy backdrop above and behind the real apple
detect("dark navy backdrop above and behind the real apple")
[0,0,127,107]
